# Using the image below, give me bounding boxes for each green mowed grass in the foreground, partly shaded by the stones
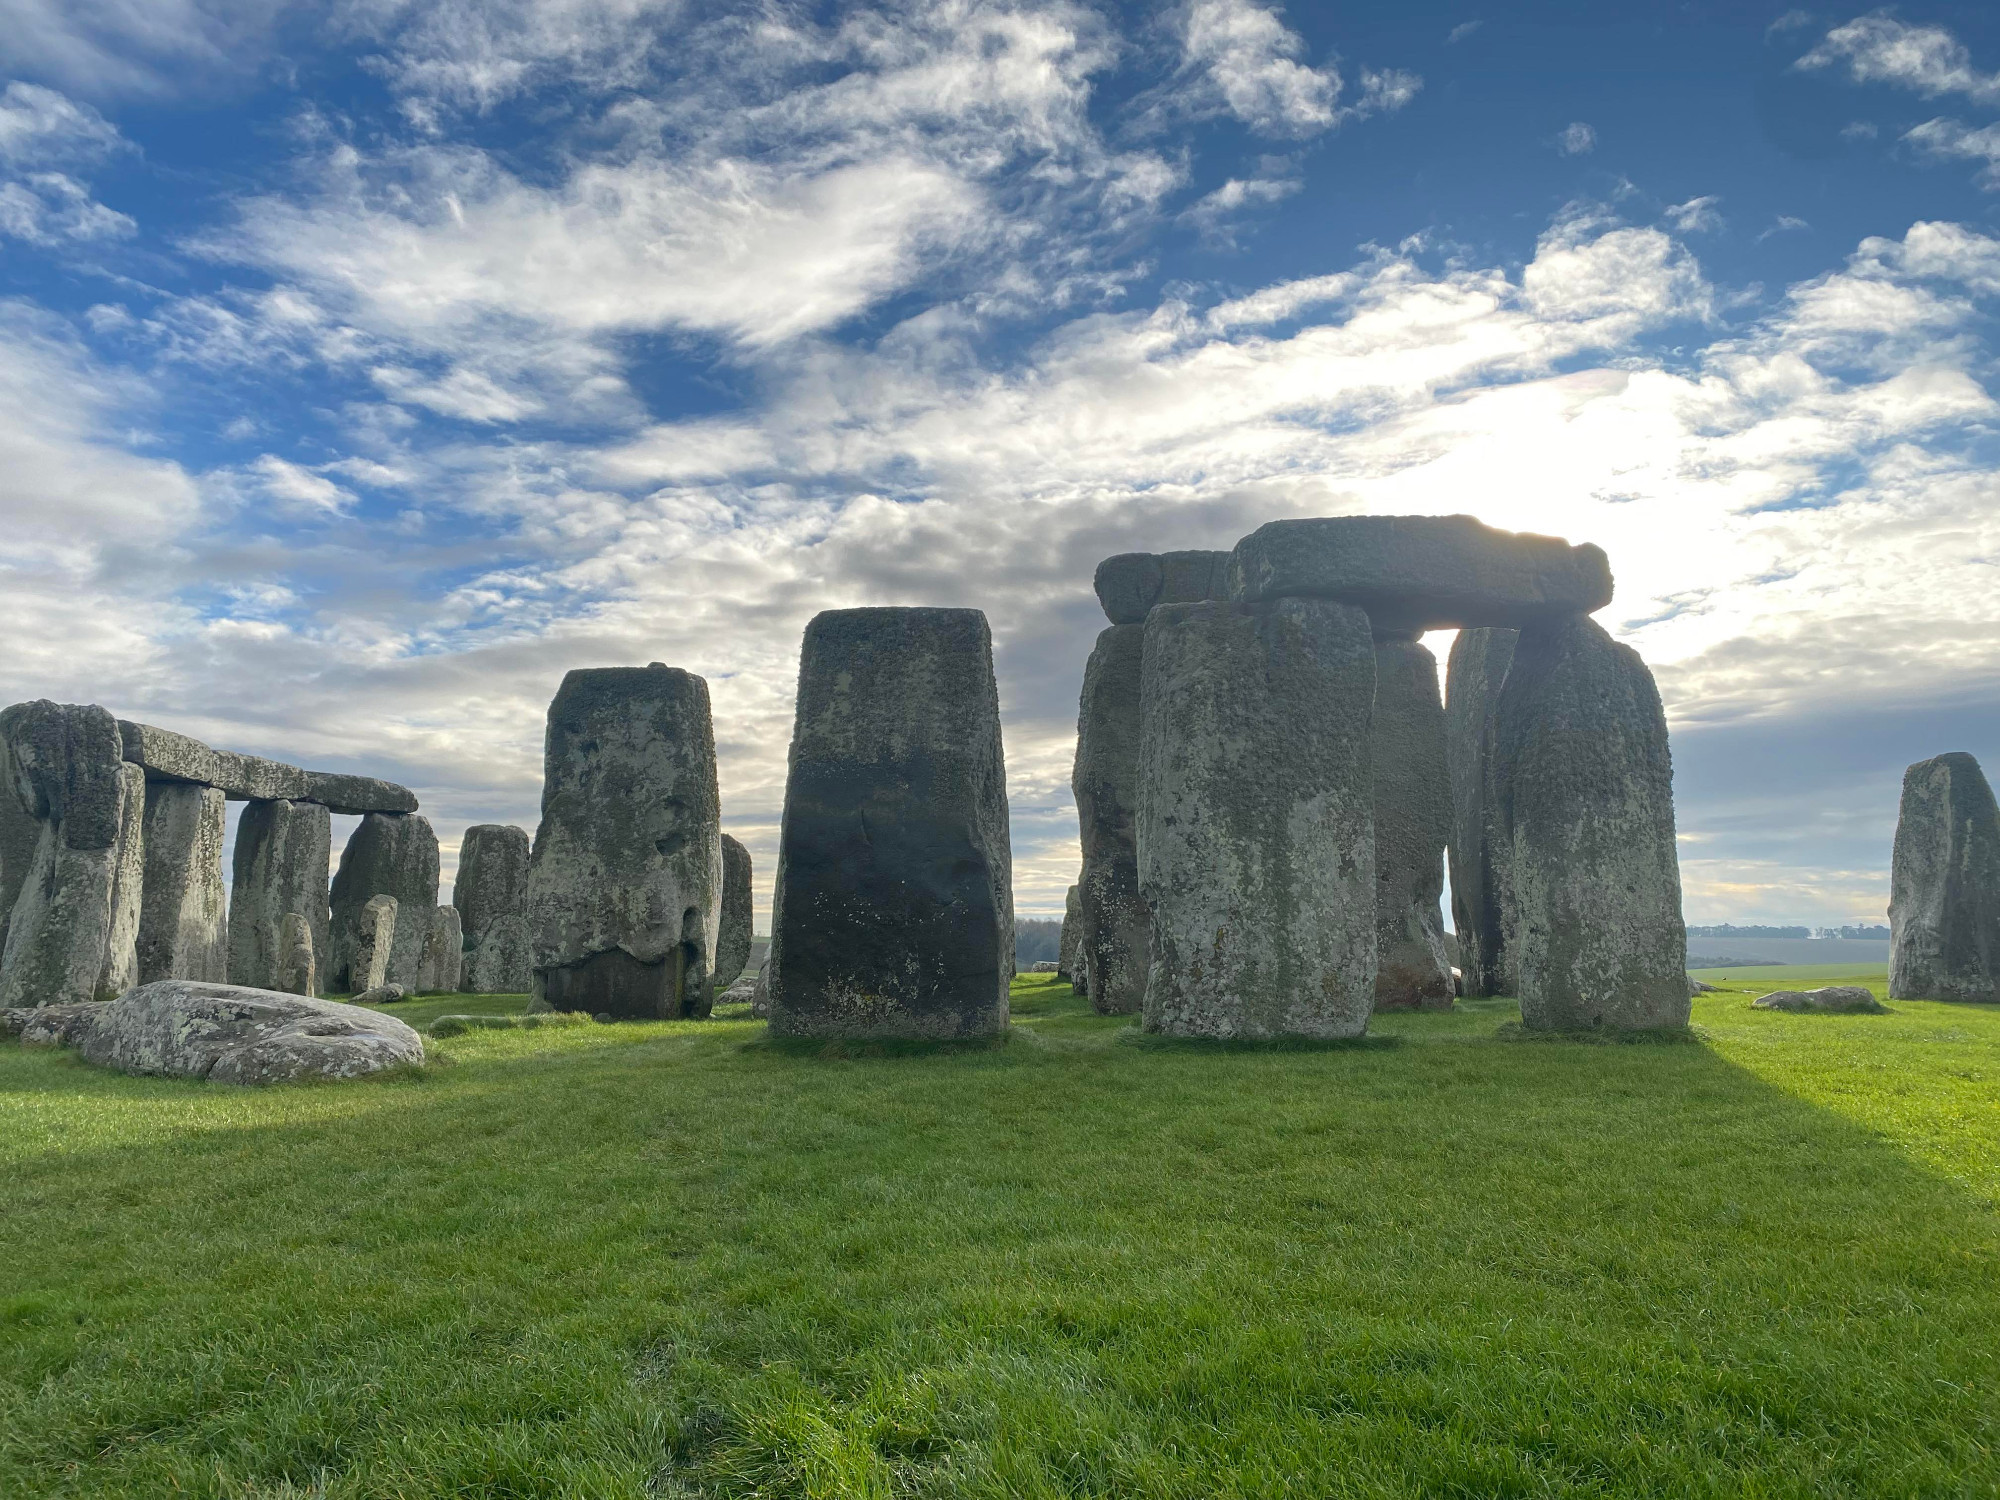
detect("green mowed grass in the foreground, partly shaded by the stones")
[0,972,2000,1500]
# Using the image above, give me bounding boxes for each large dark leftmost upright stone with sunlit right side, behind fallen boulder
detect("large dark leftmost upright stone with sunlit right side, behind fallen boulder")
[0,698,146,1006]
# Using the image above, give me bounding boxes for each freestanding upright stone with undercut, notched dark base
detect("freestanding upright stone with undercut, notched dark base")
[526,664,722,1018]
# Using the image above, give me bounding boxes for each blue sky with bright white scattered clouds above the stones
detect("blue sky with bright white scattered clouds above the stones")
[0,0,2000,930]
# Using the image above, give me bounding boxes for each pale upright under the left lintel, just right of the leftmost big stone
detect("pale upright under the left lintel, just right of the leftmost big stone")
[138,782,229,994]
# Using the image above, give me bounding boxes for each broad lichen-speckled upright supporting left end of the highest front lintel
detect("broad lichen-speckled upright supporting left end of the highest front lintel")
[1138,600,1376,1038]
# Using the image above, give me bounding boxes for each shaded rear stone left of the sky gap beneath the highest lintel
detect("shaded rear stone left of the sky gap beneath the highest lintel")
[1374,636,1452,1010]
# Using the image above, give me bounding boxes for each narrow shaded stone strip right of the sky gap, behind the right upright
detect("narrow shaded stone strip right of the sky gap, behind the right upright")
[1444,628,1520,996]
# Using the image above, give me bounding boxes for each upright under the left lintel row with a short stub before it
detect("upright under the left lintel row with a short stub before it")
[230,802,346,990]
